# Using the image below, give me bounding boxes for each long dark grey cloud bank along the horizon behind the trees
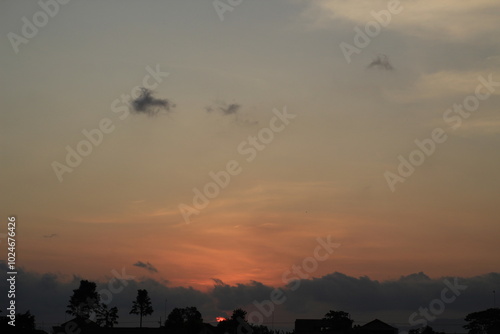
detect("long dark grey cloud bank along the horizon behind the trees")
[0,261,500,332]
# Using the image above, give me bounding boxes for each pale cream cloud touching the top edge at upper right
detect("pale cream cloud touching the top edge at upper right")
[308,0,500,41]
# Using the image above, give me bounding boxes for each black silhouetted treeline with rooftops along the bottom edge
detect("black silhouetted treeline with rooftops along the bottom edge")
[0,280,500,334]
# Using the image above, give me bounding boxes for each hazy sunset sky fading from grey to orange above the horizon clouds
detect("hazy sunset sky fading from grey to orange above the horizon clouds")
[0,0,500,332]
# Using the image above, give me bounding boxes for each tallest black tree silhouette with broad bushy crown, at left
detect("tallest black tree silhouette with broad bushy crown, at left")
[66,280,101,319]
